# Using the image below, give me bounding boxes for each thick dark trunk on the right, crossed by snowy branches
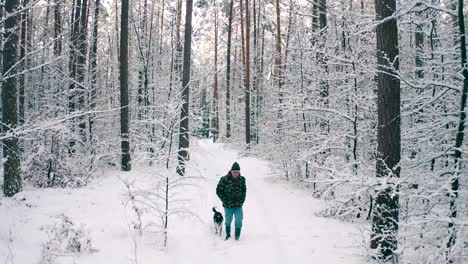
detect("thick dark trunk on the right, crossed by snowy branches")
[371,0,401,261]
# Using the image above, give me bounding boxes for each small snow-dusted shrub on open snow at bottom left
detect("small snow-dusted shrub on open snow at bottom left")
[41,215,92,264]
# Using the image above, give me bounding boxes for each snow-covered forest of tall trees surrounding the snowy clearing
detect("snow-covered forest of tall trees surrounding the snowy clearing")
[0,0,468,263]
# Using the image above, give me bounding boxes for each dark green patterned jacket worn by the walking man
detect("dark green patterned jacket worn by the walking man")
[216,172,247,208]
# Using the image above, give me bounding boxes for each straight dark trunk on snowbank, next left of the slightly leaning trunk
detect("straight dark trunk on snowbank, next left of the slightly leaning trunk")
[120,0,131,171]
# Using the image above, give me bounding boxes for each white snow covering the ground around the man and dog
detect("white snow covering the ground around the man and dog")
[0,141,367,264]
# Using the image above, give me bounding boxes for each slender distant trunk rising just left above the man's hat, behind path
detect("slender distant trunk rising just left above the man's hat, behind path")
[226,0,234,138]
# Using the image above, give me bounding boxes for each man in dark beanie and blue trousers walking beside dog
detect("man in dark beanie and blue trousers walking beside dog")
[216,162,247,240]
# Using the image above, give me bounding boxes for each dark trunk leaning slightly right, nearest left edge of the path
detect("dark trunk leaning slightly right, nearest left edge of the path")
[177,0,193,176]
